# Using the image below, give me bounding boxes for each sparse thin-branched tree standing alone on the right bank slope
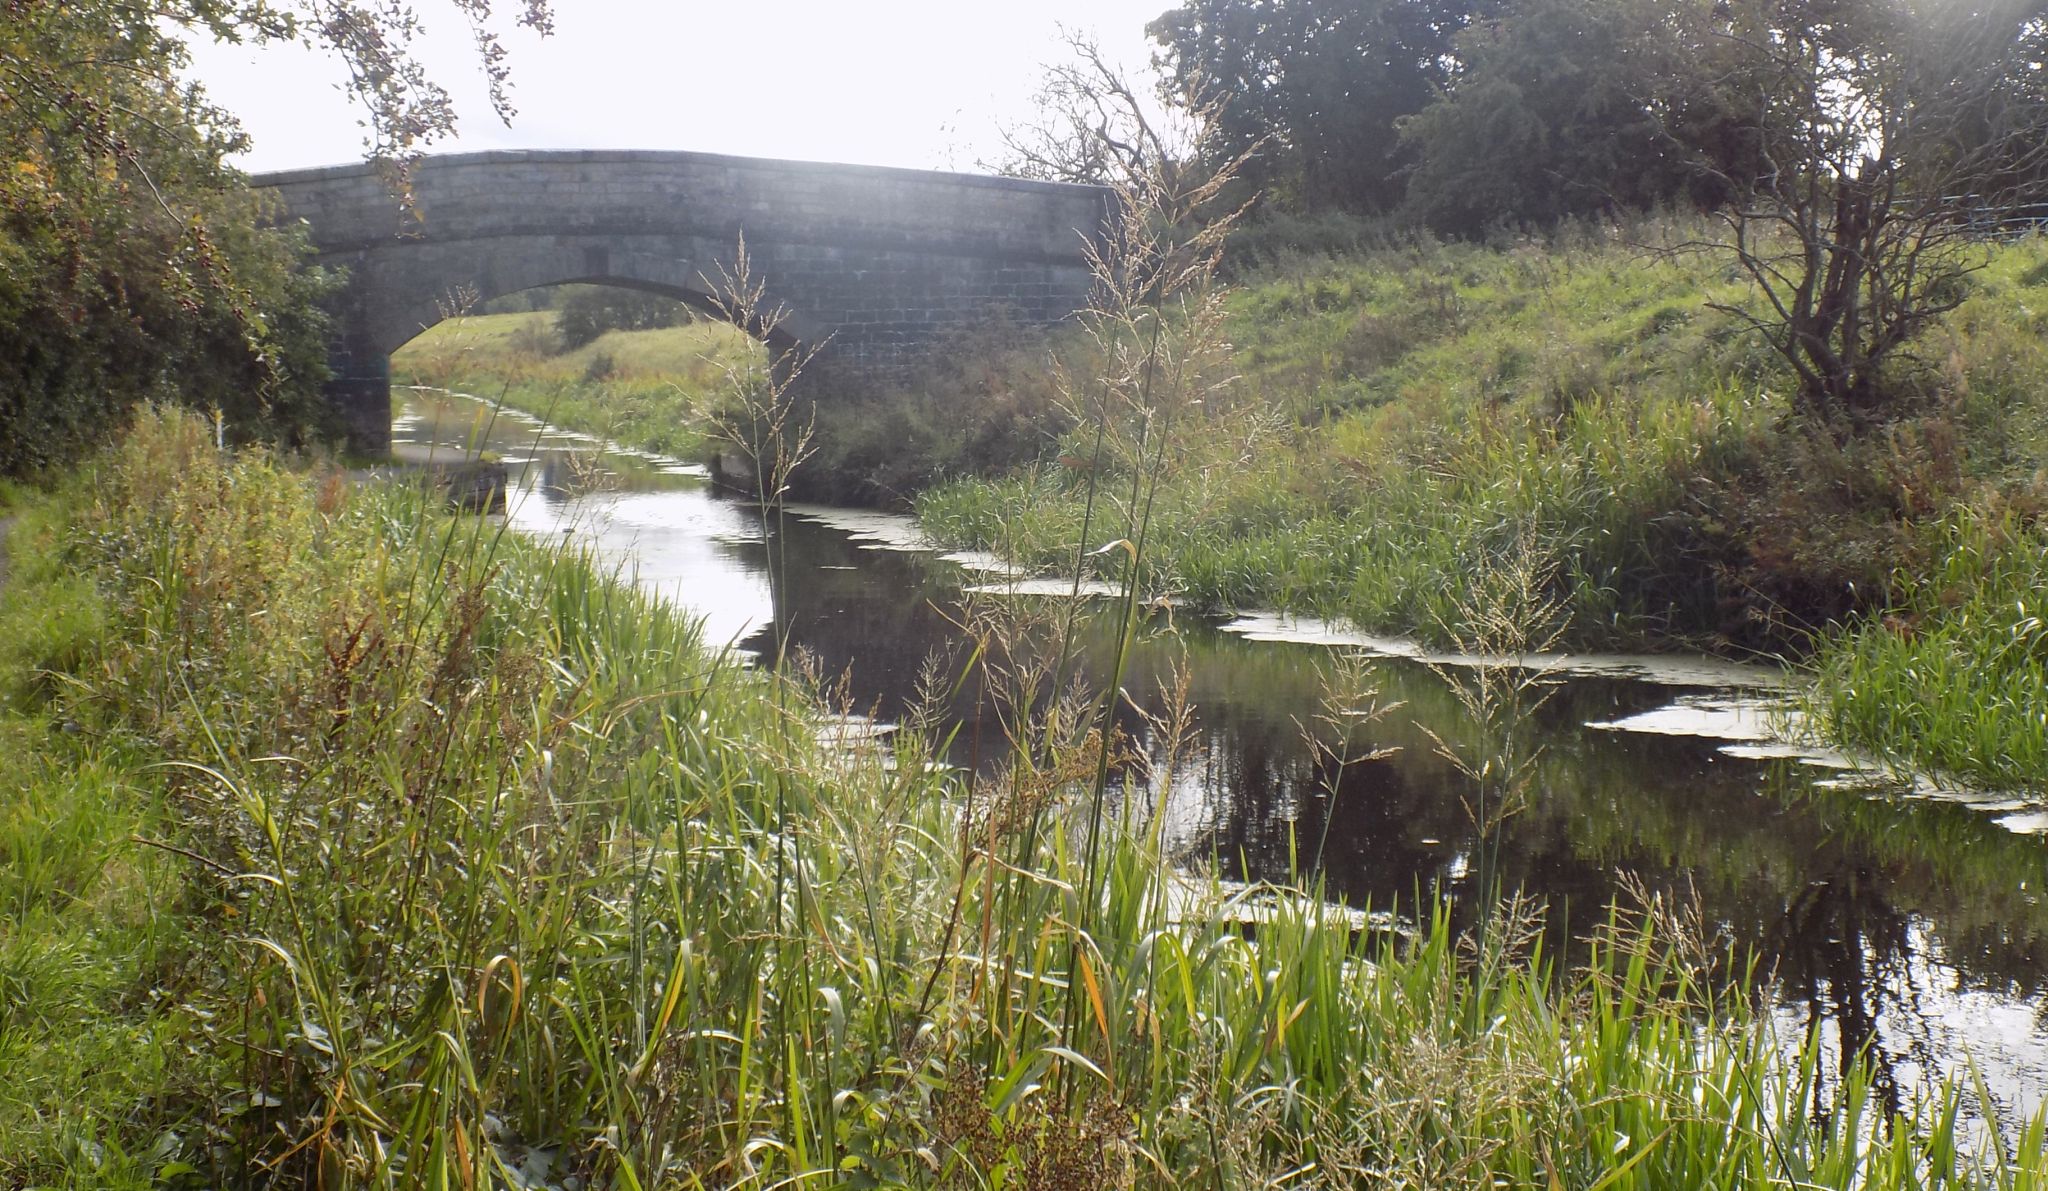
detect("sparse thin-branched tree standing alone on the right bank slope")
[1688,0,2048,420]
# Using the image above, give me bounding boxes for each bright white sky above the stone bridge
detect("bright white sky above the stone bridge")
[193,0,1174,172]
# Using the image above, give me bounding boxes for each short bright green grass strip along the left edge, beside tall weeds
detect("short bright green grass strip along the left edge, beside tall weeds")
[0,489,215,1187]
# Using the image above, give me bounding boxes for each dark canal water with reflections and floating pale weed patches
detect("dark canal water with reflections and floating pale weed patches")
[393,393,2048,1121]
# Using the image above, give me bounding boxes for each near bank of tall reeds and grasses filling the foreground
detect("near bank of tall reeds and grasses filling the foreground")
[0,411,2042,1187]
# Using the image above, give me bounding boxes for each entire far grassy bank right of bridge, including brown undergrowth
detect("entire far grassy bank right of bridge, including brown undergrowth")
[918,223,2048,790]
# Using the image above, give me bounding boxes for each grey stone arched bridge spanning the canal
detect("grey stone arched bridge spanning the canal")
[252,149,1114,452]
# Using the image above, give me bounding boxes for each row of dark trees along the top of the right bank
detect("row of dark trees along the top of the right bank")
[1149,0,2048,257]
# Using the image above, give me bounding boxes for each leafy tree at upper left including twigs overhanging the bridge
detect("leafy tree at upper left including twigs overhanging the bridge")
[0,0,549,473]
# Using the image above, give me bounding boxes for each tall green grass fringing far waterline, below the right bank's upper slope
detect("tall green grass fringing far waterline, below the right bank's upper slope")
[918,378,1774,647]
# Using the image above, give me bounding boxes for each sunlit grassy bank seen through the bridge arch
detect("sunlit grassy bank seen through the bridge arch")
[391,311,760,460]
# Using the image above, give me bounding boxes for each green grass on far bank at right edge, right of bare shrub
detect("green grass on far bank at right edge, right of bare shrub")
[1808,239,2048,796]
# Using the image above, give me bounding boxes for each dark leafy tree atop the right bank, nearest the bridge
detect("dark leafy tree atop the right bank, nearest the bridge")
[1147,0,1501,211]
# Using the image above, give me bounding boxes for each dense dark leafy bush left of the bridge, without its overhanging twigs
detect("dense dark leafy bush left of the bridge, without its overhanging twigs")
[0,4,334,475]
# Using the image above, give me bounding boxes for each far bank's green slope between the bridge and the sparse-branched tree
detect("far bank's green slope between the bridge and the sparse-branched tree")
[937,222,1769,645]
